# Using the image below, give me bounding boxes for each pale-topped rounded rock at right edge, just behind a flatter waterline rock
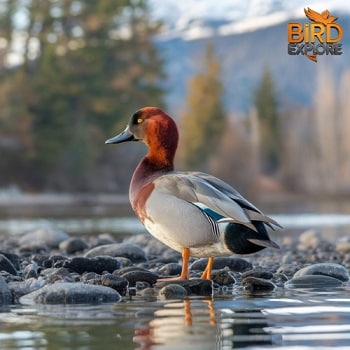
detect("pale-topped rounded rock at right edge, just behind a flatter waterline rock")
[293,263,349,282]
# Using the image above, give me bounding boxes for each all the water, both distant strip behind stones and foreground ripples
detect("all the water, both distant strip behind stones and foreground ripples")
[0,196,350,350]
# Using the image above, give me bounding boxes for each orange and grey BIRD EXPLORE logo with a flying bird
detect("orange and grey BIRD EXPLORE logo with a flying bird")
[288,7,343,62]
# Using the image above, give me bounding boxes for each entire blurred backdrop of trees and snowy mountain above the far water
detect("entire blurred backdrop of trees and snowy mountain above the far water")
[0,0,350,202]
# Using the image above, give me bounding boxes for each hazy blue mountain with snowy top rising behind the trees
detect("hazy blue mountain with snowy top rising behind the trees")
[153,0,350,114]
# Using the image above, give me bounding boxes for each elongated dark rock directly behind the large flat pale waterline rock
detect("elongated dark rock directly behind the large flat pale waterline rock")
[63,256,122,274]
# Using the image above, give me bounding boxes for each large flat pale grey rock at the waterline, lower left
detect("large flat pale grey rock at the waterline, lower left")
[19,282,121,305]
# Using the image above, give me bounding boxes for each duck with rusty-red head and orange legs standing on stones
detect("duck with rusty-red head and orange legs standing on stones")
[105,107,281,280]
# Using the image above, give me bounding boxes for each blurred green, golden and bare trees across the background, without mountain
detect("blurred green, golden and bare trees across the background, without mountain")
[0,0,350,195]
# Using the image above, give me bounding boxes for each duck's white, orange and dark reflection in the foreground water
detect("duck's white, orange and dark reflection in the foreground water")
[133,299,276,350]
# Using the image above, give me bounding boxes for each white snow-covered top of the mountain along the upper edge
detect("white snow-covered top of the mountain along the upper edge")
[149,0,350,40]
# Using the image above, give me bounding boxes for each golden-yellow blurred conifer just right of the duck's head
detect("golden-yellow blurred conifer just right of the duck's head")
[179,44,226,168]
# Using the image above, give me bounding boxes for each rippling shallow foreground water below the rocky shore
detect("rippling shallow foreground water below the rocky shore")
[0,288,350,350]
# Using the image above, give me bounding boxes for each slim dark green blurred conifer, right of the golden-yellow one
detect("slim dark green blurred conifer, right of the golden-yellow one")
[254,67,281,175]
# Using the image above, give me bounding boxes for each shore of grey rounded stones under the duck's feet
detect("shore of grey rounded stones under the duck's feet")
[0,228,350,305]
